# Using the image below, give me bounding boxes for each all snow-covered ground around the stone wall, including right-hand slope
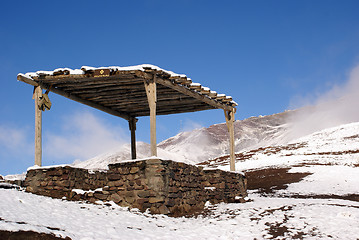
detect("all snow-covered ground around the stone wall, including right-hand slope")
[0,123,359,239]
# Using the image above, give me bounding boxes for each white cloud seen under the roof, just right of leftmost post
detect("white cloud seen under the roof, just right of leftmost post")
[44,112,128,162]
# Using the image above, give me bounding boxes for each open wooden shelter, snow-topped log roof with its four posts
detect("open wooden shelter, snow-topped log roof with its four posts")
[17,64,237,171]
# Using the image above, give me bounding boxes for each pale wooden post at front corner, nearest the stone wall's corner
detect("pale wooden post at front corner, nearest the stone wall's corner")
[145,74,157,157]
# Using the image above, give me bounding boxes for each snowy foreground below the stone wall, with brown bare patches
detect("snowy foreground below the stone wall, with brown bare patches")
[0,189,359,239]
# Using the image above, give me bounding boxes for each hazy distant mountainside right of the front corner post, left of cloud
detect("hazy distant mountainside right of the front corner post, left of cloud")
[158,111,293,162]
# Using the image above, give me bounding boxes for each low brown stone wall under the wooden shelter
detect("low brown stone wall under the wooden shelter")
[24,159,247,216]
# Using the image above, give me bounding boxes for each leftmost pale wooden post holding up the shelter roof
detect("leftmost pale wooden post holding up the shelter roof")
[33,86,42,167]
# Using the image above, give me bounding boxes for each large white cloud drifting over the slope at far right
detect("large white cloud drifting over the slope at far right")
[291,65,359,139]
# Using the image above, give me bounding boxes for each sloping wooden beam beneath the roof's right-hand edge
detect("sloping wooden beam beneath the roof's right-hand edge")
[156,78,233,111]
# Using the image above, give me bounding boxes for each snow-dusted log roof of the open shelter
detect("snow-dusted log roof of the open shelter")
[17,64,237,120]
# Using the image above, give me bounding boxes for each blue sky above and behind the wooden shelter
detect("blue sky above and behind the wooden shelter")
[0,0,359,175]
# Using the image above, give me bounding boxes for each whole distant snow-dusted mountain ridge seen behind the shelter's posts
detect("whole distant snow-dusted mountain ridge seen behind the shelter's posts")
[73,111,293,169]
